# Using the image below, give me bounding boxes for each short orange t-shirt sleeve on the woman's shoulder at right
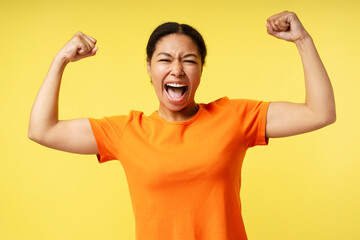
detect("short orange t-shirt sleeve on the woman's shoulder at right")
[230,99,270,147]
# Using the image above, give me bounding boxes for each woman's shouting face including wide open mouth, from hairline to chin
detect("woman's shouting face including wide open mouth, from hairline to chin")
[147,34,202,111]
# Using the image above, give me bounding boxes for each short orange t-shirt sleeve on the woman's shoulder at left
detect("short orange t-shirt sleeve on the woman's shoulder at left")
[89,115,130,163]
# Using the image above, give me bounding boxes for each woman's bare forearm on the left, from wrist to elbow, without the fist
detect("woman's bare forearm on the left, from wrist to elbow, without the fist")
[28,56,66,139]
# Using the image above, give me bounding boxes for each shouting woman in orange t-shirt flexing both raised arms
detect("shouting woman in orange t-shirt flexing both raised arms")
[28,11,335,240]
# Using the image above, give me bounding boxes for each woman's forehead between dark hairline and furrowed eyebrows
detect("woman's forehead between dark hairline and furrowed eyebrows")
[155,33,198,55]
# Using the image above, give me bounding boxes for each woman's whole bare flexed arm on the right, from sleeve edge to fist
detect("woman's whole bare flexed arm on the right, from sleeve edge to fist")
[266,11,336,138]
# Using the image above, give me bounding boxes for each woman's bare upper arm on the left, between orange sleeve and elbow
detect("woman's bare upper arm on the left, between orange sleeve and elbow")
[39,118,98,154]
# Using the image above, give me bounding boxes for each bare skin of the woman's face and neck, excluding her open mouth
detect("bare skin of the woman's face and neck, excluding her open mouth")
[147,34,202,121]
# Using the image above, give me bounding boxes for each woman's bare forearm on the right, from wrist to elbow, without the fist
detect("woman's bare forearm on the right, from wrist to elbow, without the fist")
[295,34,336,123]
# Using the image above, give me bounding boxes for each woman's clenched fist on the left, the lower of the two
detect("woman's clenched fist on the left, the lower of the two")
[57,32,98,63]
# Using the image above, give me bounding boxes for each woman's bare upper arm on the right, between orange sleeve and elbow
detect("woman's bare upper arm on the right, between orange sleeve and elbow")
[266,102,327,138]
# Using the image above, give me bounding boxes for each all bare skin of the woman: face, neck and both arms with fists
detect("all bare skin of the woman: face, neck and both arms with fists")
[28,11,336,154]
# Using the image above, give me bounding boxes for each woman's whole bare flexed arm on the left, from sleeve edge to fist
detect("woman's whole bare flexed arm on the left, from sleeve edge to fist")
[28,32,98,154]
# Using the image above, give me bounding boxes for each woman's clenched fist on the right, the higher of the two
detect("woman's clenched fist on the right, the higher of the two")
[266,11,309,43]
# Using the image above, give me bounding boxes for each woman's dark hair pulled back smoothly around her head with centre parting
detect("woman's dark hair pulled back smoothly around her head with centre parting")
[146,22,206,65]
